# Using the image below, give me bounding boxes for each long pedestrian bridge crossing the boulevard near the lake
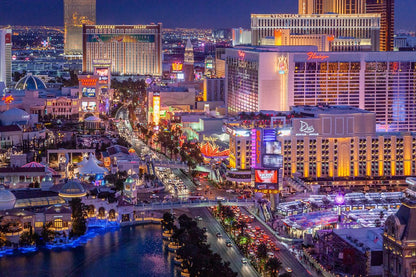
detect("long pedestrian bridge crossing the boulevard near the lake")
[134,199,256,212]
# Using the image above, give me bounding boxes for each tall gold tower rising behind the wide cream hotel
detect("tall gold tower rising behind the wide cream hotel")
[64,0,96,58]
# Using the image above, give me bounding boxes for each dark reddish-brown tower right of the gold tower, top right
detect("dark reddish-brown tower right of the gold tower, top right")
[366,0,394,51]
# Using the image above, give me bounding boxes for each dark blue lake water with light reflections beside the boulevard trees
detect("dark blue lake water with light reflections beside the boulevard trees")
[0,225,178,277]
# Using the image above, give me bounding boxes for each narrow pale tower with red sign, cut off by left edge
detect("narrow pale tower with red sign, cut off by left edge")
[0,29,12,86]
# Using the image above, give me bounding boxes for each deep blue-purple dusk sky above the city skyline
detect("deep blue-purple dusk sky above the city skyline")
[0,0,416,30]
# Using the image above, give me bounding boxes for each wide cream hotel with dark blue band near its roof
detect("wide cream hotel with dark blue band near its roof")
[82,23,162,76]
